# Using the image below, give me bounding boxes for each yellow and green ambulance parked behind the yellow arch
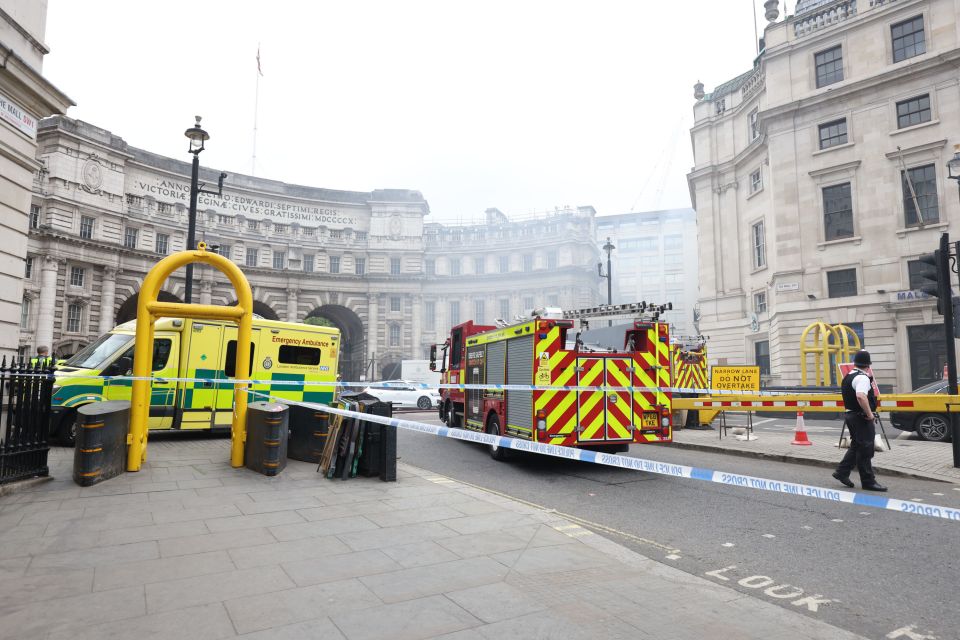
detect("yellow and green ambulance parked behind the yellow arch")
[50,318,340,445]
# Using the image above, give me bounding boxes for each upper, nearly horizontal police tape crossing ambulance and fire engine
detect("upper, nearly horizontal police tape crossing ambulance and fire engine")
[28,373,816,396]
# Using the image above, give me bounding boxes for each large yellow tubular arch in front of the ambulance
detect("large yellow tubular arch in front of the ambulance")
[127,242,253,471]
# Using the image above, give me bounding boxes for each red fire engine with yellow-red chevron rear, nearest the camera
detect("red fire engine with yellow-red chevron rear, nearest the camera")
[430,302,672,460]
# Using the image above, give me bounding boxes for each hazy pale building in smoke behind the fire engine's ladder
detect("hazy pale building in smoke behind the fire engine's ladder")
[596,209,697,336]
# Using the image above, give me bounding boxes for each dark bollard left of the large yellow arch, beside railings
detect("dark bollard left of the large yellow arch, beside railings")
[73,400,130,487]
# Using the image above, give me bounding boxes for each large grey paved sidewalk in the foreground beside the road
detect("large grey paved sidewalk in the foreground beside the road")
[0,440,858,640]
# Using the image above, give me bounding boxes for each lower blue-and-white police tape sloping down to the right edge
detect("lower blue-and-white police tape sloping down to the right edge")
[251,391,960,521]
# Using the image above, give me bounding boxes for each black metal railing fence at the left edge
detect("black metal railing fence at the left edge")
[0,357,53,484]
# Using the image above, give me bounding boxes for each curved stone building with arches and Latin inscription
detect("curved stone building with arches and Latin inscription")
[20,116,596,380]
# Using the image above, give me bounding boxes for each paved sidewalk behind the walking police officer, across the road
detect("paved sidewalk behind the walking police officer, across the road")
[673,423,960,483]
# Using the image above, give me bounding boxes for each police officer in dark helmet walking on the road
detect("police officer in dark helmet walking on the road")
[833,350,887,491]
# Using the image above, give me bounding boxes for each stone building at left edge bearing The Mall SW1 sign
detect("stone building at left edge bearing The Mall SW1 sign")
[0,0,73,357]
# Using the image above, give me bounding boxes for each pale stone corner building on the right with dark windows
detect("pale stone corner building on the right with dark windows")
[688,0,960,390]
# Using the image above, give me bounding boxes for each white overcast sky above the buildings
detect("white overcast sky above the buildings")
[44,0,793,222]
